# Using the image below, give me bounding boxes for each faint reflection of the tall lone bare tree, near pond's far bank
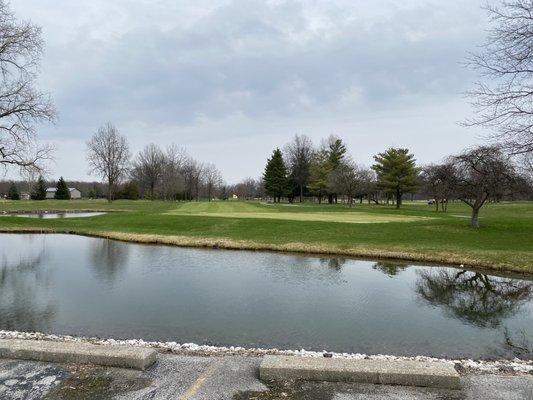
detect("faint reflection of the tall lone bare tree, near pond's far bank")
[90,239,130,284]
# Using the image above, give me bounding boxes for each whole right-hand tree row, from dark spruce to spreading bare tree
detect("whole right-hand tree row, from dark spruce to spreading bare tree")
[263,135,532,227]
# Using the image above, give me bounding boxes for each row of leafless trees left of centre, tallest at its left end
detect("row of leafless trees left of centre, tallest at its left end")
[87,123,223,201]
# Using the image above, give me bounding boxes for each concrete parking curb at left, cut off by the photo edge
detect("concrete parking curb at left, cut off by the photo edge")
[0,339,157,370]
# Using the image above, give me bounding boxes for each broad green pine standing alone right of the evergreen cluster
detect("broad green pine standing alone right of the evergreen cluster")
[372,148,418,208]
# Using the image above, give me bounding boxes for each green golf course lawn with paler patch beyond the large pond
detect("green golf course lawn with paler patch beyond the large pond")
[0,200,533,273]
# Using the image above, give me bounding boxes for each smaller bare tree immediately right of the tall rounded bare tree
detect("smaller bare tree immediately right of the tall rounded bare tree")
[131,143,165,200]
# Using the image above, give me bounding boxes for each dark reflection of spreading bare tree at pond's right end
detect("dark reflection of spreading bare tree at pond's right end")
[415,270,533,328]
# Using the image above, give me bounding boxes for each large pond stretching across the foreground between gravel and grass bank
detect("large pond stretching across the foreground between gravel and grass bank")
[0,234,533,358]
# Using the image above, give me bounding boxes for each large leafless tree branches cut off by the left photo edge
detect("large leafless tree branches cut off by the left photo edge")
[0,0,56,173]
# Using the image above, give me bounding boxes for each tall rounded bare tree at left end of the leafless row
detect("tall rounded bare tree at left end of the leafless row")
[87,122,130,201]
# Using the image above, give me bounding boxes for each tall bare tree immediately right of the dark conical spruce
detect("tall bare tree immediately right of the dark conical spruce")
[285,135,314,203]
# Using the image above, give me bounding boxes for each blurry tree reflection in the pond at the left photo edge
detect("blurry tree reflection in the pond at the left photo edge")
[0,250,55,331]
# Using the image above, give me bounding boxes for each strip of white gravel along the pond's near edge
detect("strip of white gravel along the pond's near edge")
[0,330,533,374]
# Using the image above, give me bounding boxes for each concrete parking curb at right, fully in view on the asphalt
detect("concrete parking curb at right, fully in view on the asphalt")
[259,356,461,389]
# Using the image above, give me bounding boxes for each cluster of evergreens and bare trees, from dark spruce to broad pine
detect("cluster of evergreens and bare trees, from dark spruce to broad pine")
[263,135,418,208]
